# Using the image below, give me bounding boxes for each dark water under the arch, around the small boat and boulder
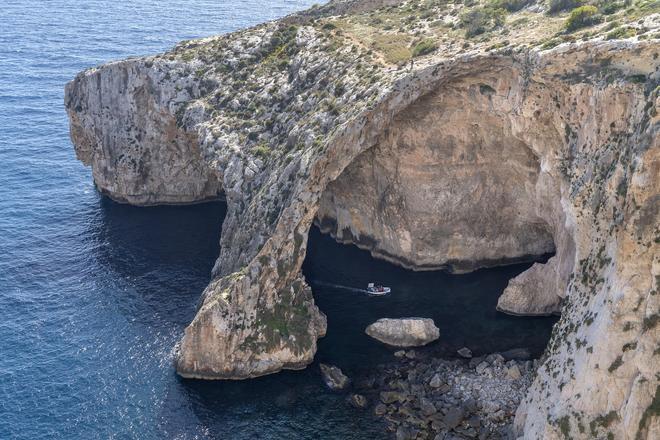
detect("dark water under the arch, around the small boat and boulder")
[303,226,557,371]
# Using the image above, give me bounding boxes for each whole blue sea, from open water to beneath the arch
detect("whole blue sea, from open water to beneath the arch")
[0,0,554,439]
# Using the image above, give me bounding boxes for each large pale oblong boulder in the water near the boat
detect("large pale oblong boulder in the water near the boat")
[365,318,440,347]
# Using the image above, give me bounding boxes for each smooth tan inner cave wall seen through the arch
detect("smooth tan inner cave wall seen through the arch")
[318,77,559,273]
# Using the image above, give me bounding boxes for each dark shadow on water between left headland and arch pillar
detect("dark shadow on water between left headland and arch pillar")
[95,197,226,325]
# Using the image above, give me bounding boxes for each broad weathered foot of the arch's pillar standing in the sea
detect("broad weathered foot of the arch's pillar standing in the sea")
[176,273,326,379]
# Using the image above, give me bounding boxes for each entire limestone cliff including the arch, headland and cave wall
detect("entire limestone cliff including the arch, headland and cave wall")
[65,2,660,438]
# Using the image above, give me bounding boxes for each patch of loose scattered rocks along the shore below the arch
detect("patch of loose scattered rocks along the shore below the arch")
[324,349,538,440]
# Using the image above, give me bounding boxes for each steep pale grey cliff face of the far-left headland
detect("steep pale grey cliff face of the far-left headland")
[65,60,222,205]
